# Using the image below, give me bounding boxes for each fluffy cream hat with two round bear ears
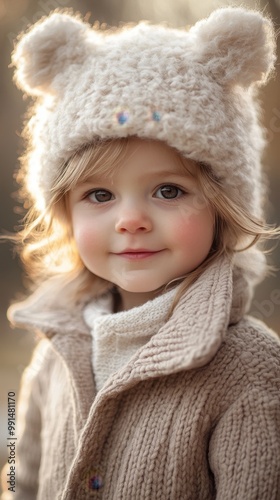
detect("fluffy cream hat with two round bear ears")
[13,8,275,215]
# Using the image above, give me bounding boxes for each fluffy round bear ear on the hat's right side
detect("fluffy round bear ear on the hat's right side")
[189,7,276,87]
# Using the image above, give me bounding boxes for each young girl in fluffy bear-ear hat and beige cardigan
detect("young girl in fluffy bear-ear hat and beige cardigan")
[2,8,280,500]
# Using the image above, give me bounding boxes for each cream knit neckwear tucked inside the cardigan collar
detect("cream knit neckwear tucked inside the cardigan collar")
[83,288,177,391]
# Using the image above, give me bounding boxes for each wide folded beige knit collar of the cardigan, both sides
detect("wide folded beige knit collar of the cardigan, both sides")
[6,257,247,378]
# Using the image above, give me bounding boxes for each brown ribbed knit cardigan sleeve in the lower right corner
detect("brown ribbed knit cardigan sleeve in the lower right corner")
[209,383,280,500]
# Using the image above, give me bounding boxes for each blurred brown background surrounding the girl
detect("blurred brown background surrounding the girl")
[0,0,280,480]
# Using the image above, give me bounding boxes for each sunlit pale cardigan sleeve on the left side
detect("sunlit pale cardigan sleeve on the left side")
[1,341,47,500]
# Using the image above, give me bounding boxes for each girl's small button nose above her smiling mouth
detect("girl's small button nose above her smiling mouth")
[115,209,152,234]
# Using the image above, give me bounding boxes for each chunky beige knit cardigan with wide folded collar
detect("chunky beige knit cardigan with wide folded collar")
[2,259,280,500]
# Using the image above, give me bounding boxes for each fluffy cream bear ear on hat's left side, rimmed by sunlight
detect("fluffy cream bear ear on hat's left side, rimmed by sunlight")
[12,12,91,96]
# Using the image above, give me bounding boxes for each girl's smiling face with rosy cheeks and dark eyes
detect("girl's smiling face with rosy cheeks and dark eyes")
[70,138,214,309]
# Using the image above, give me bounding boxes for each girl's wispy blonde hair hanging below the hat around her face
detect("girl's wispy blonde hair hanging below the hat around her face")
[12,138,278,310]
